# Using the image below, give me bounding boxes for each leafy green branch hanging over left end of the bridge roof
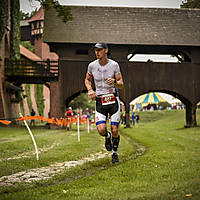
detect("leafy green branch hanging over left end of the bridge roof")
[38,0,73,23]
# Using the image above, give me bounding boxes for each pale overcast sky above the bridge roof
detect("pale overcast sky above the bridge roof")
[20,0,183,12]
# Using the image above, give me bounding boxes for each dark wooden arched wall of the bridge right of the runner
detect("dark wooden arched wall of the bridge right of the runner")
[115,62,200,127]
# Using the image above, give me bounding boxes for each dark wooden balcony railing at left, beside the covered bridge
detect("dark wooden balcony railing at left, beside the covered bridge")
[5,59,59,84]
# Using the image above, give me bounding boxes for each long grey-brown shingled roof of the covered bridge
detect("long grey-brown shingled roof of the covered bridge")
[43,6,200,46]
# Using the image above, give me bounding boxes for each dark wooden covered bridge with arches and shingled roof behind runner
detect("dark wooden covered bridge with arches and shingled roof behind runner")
[43,6,200,127]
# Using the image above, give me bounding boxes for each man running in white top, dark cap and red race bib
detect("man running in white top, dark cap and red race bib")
[85,42,124,163]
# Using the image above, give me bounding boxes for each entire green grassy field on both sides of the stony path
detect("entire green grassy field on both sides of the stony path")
[0,110,200,200]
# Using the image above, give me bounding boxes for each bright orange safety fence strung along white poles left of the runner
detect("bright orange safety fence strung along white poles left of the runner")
[0,116,95,127]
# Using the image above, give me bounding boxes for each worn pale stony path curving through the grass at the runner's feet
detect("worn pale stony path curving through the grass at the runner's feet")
[0,134,146,187]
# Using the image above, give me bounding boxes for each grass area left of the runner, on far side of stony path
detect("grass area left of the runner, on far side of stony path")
[0,127,106,176]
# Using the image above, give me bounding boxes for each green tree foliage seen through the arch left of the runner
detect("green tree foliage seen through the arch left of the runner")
[69,93,95,110]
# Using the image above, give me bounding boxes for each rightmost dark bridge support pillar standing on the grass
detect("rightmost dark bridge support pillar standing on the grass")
[185,103,197,128]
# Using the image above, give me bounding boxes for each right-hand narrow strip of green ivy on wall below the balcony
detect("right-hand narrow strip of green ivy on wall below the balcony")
[34,84,44,116]
